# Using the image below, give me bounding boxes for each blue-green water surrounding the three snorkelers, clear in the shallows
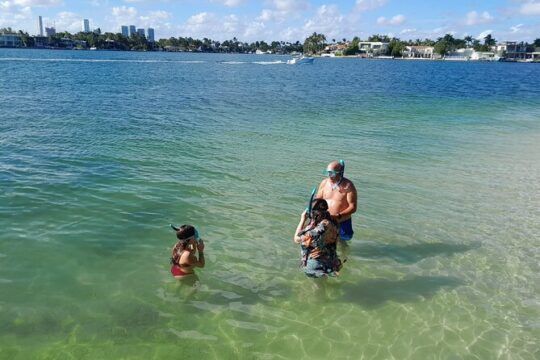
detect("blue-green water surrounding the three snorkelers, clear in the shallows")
[0,50,540,359]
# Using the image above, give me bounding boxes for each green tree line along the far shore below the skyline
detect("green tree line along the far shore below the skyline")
[0,28,540,57]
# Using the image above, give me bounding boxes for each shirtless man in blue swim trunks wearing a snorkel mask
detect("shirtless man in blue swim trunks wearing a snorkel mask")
[317,160,357,241]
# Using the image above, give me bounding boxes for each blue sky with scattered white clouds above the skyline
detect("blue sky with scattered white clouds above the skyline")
[0,0,540,42]
